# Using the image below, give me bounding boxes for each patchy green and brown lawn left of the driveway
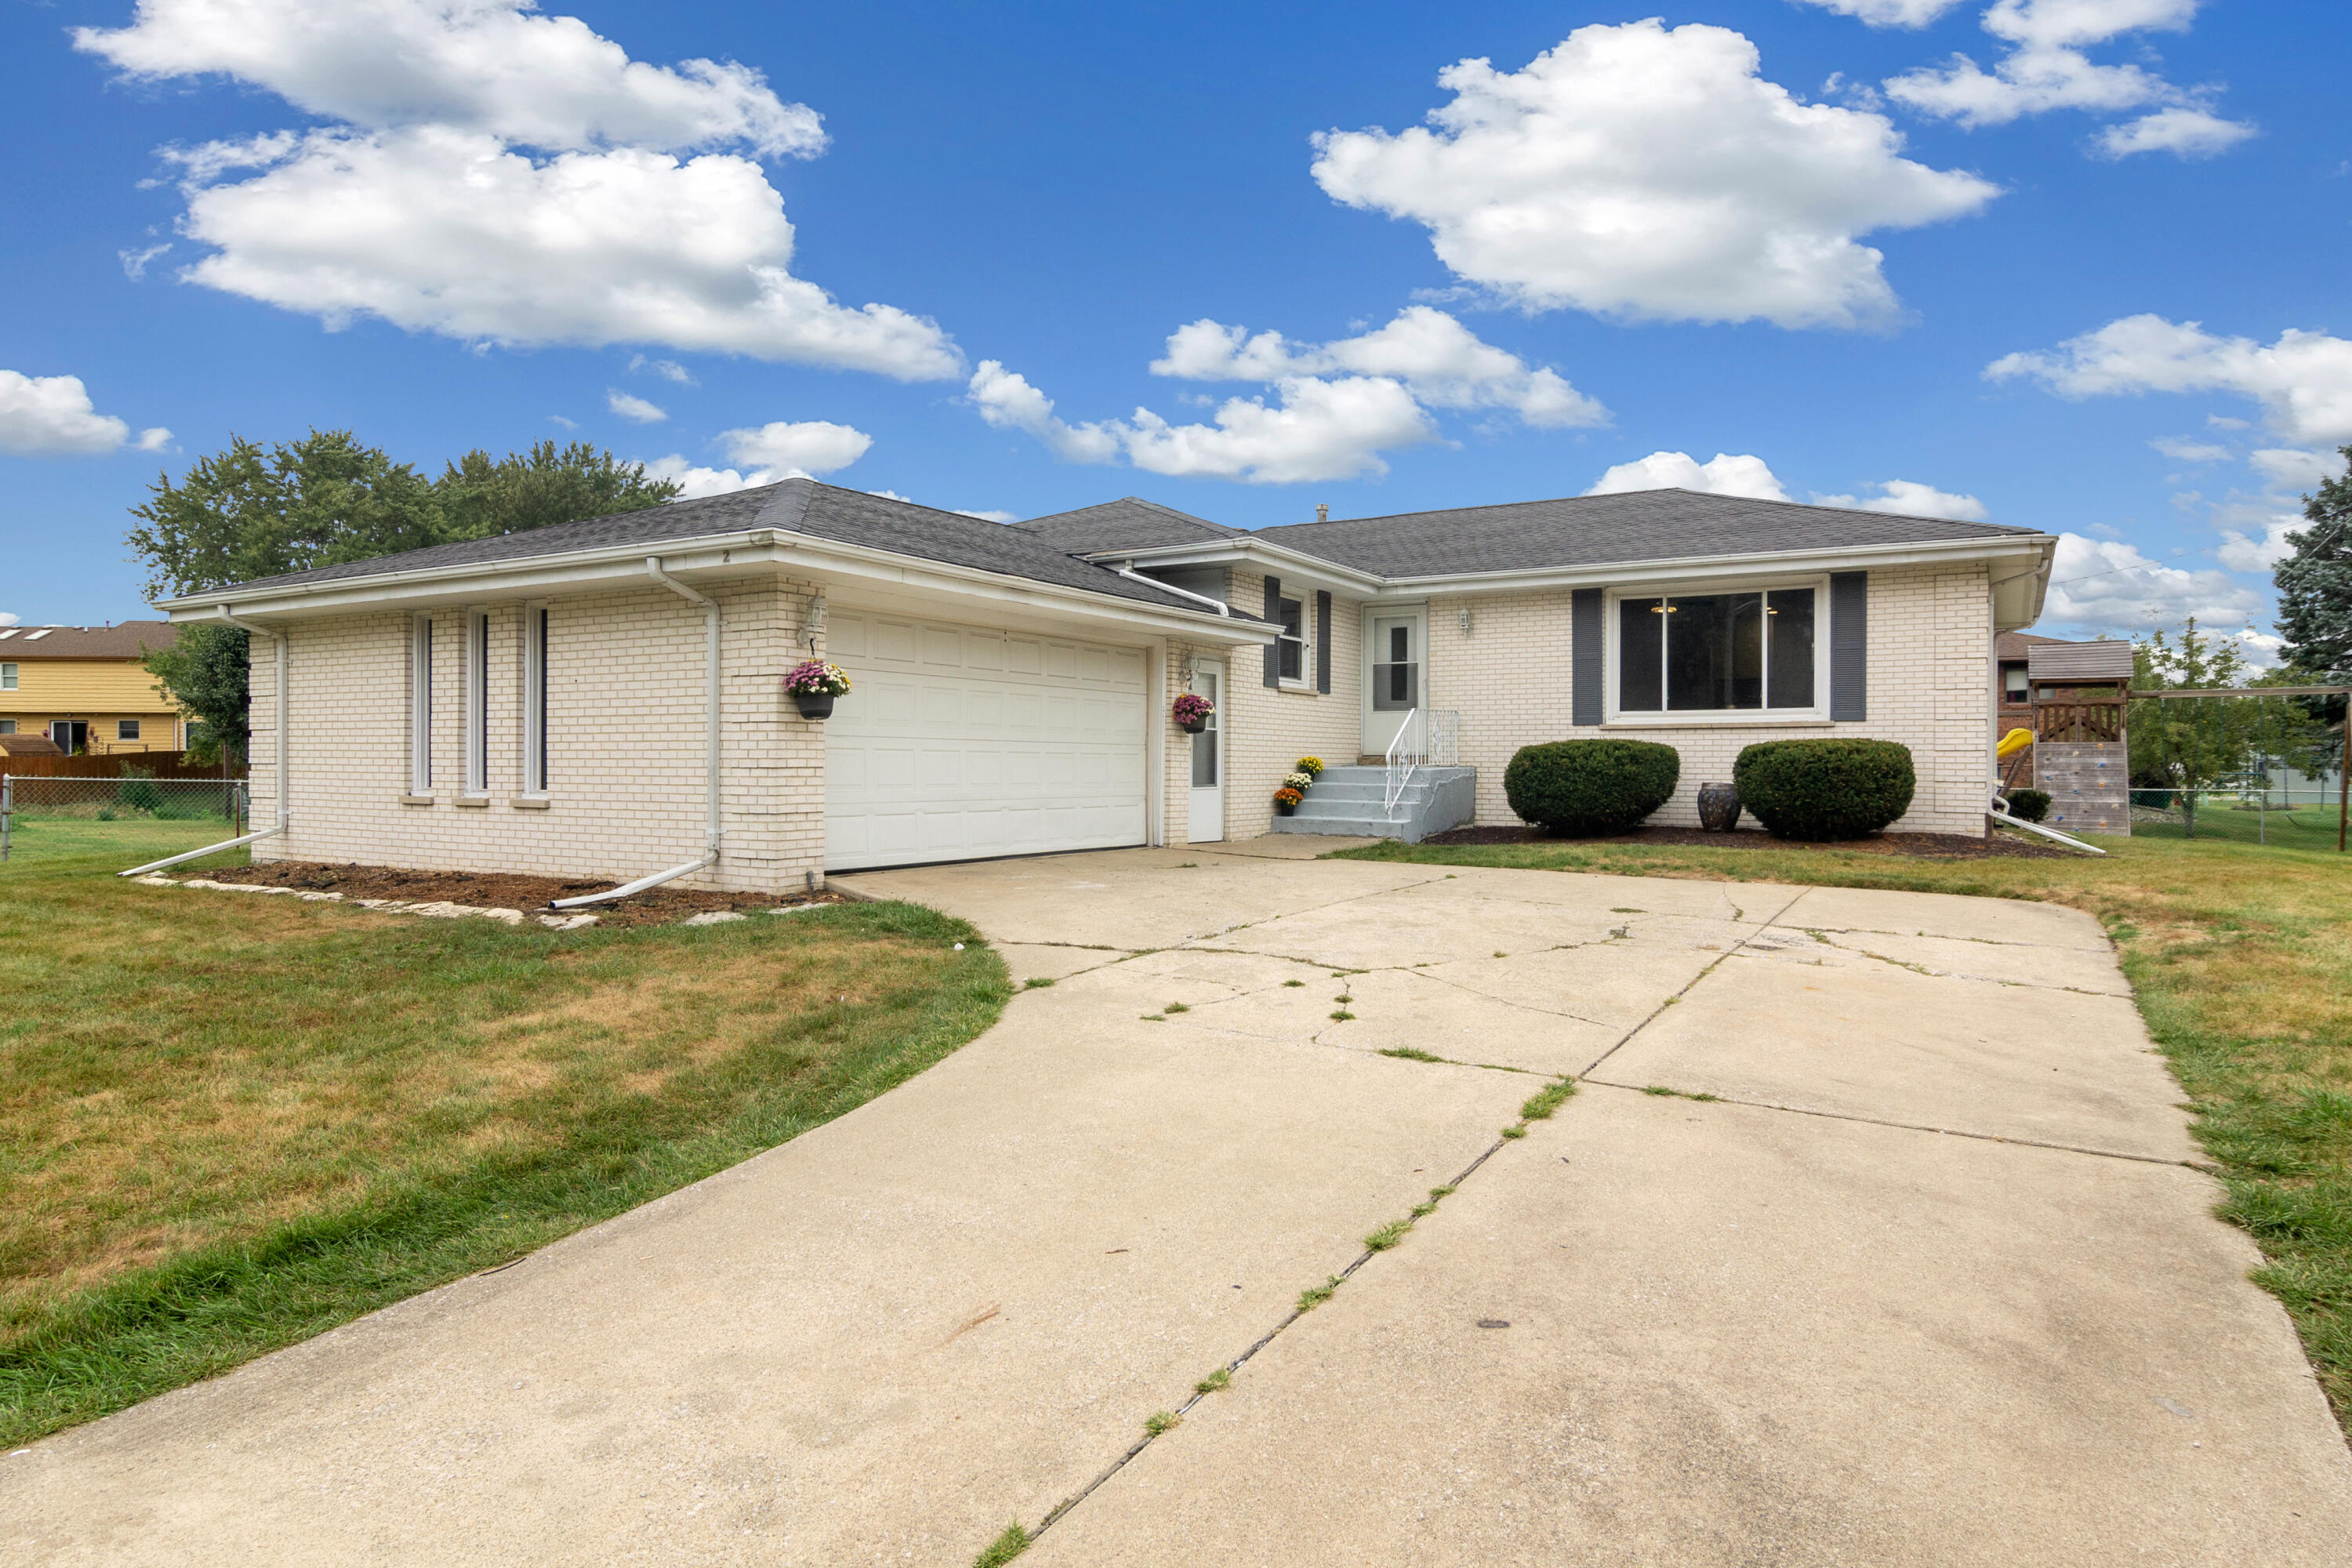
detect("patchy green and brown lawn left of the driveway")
[0,825,1011,1446]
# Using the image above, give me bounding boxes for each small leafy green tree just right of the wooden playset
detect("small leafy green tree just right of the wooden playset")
[2129,616,2326,837]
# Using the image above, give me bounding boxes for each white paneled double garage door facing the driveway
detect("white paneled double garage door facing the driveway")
[826,609,1145,869]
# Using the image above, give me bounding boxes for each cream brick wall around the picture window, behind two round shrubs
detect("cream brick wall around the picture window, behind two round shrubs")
[1428,564,1992,834]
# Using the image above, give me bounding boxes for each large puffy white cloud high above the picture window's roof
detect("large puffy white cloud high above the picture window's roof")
[1315,19,1997,327]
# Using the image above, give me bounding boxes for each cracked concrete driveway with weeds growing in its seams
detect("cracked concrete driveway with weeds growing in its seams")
[0,839,2352,1568]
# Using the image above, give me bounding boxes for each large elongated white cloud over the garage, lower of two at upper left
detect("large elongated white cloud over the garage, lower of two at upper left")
[165,125,960,381]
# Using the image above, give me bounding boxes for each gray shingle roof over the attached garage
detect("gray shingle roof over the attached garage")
[191,480,1214,612]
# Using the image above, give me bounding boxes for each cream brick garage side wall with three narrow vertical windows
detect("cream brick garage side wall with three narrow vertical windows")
[252,579,826,891]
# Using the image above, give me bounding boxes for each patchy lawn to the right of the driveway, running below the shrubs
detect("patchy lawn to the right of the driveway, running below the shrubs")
[1338,820,2352,1427]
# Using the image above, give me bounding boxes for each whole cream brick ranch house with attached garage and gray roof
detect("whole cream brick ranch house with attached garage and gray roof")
[162,480,2056,891]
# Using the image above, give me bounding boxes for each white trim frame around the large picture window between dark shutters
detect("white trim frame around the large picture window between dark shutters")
[1602,574,1830,729]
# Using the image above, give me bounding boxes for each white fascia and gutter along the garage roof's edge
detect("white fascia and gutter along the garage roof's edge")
[158,529,1275,647]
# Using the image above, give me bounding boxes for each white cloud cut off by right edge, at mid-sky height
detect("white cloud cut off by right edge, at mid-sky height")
[1985,315,2352,447]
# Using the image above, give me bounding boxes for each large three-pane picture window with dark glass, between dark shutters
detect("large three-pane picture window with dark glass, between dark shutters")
[1616,588,1820,715]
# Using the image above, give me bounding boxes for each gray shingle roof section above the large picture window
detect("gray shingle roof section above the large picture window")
[1251,489,2034,576]
